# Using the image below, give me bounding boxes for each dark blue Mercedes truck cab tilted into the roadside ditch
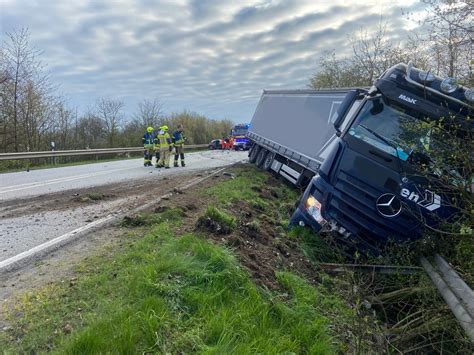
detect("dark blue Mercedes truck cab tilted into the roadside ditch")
[290,63,474,249]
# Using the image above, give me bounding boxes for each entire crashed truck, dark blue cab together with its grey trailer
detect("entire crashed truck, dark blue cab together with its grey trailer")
[248,62,474,251]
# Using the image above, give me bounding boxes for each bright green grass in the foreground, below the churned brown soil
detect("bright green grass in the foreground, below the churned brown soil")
[0,211,351,354]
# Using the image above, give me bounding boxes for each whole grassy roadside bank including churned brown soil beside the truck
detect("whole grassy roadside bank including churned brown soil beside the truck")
[0,167,364,354]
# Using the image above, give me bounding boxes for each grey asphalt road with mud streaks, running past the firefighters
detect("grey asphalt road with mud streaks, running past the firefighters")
[0,151,247,262]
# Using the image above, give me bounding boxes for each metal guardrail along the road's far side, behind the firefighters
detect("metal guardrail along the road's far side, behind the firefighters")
[0,144,208,160]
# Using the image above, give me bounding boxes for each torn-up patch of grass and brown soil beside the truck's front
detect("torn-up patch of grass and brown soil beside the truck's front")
[189,165,330,290]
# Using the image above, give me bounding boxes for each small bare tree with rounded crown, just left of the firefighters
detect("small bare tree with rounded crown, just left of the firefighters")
[95,98,124,147]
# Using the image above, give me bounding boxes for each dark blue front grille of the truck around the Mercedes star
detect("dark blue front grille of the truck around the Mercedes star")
[327,170,420,244]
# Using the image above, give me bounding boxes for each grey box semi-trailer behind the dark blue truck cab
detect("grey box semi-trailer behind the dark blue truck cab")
[248,89,349,186]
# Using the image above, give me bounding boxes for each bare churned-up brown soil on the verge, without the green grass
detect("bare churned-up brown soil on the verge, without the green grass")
[169,170,319,290]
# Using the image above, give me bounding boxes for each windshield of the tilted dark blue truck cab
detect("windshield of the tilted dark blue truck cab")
[348,97,449,169]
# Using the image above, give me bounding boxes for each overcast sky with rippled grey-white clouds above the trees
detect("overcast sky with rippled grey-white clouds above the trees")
[0,0,419,122]
